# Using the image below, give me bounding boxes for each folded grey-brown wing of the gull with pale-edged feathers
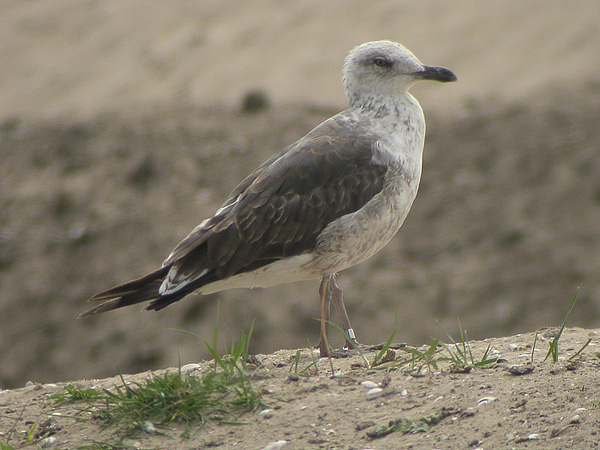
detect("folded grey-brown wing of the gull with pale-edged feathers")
[160,122,386,295]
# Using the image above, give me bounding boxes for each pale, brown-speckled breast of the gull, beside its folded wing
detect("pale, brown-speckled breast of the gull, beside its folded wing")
[314,103,425,273]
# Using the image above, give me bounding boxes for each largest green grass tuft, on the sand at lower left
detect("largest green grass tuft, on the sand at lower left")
[52,320,267,445]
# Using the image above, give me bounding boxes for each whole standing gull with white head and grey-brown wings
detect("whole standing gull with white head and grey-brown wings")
[80,41,456,356]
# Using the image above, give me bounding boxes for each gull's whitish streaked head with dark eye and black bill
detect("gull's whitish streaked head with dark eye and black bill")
[342,41,456,106]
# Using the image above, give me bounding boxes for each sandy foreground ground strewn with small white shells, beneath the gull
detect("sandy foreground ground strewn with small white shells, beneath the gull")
[0,328,600,449]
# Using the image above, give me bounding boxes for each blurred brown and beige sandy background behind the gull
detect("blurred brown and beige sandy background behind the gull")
[0,0,600,388]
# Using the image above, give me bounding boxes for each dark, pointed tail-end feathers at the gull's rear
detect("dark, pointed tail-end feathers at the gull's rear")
[79,267,172,317]
